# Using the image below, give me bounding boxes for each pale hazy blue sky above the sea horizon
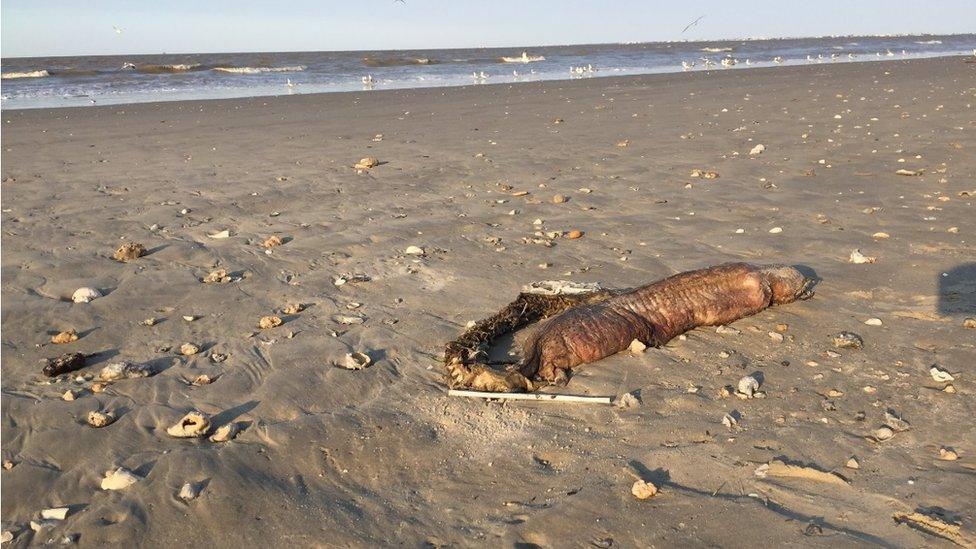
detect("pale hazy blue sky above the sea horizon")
[0,0,976,57]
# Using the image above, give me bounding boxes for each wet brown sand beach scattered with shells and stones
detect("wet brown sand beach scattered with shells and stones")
[0,58,976,547]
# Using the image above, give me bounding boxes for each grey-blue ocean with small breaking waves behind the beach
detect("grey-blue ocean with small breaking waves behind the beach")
[0,34,976,109]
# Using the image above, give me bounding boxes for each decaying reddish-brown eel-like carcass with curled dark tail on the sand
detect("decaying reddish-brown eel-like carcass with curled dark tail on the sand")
[445,263,814,392]
